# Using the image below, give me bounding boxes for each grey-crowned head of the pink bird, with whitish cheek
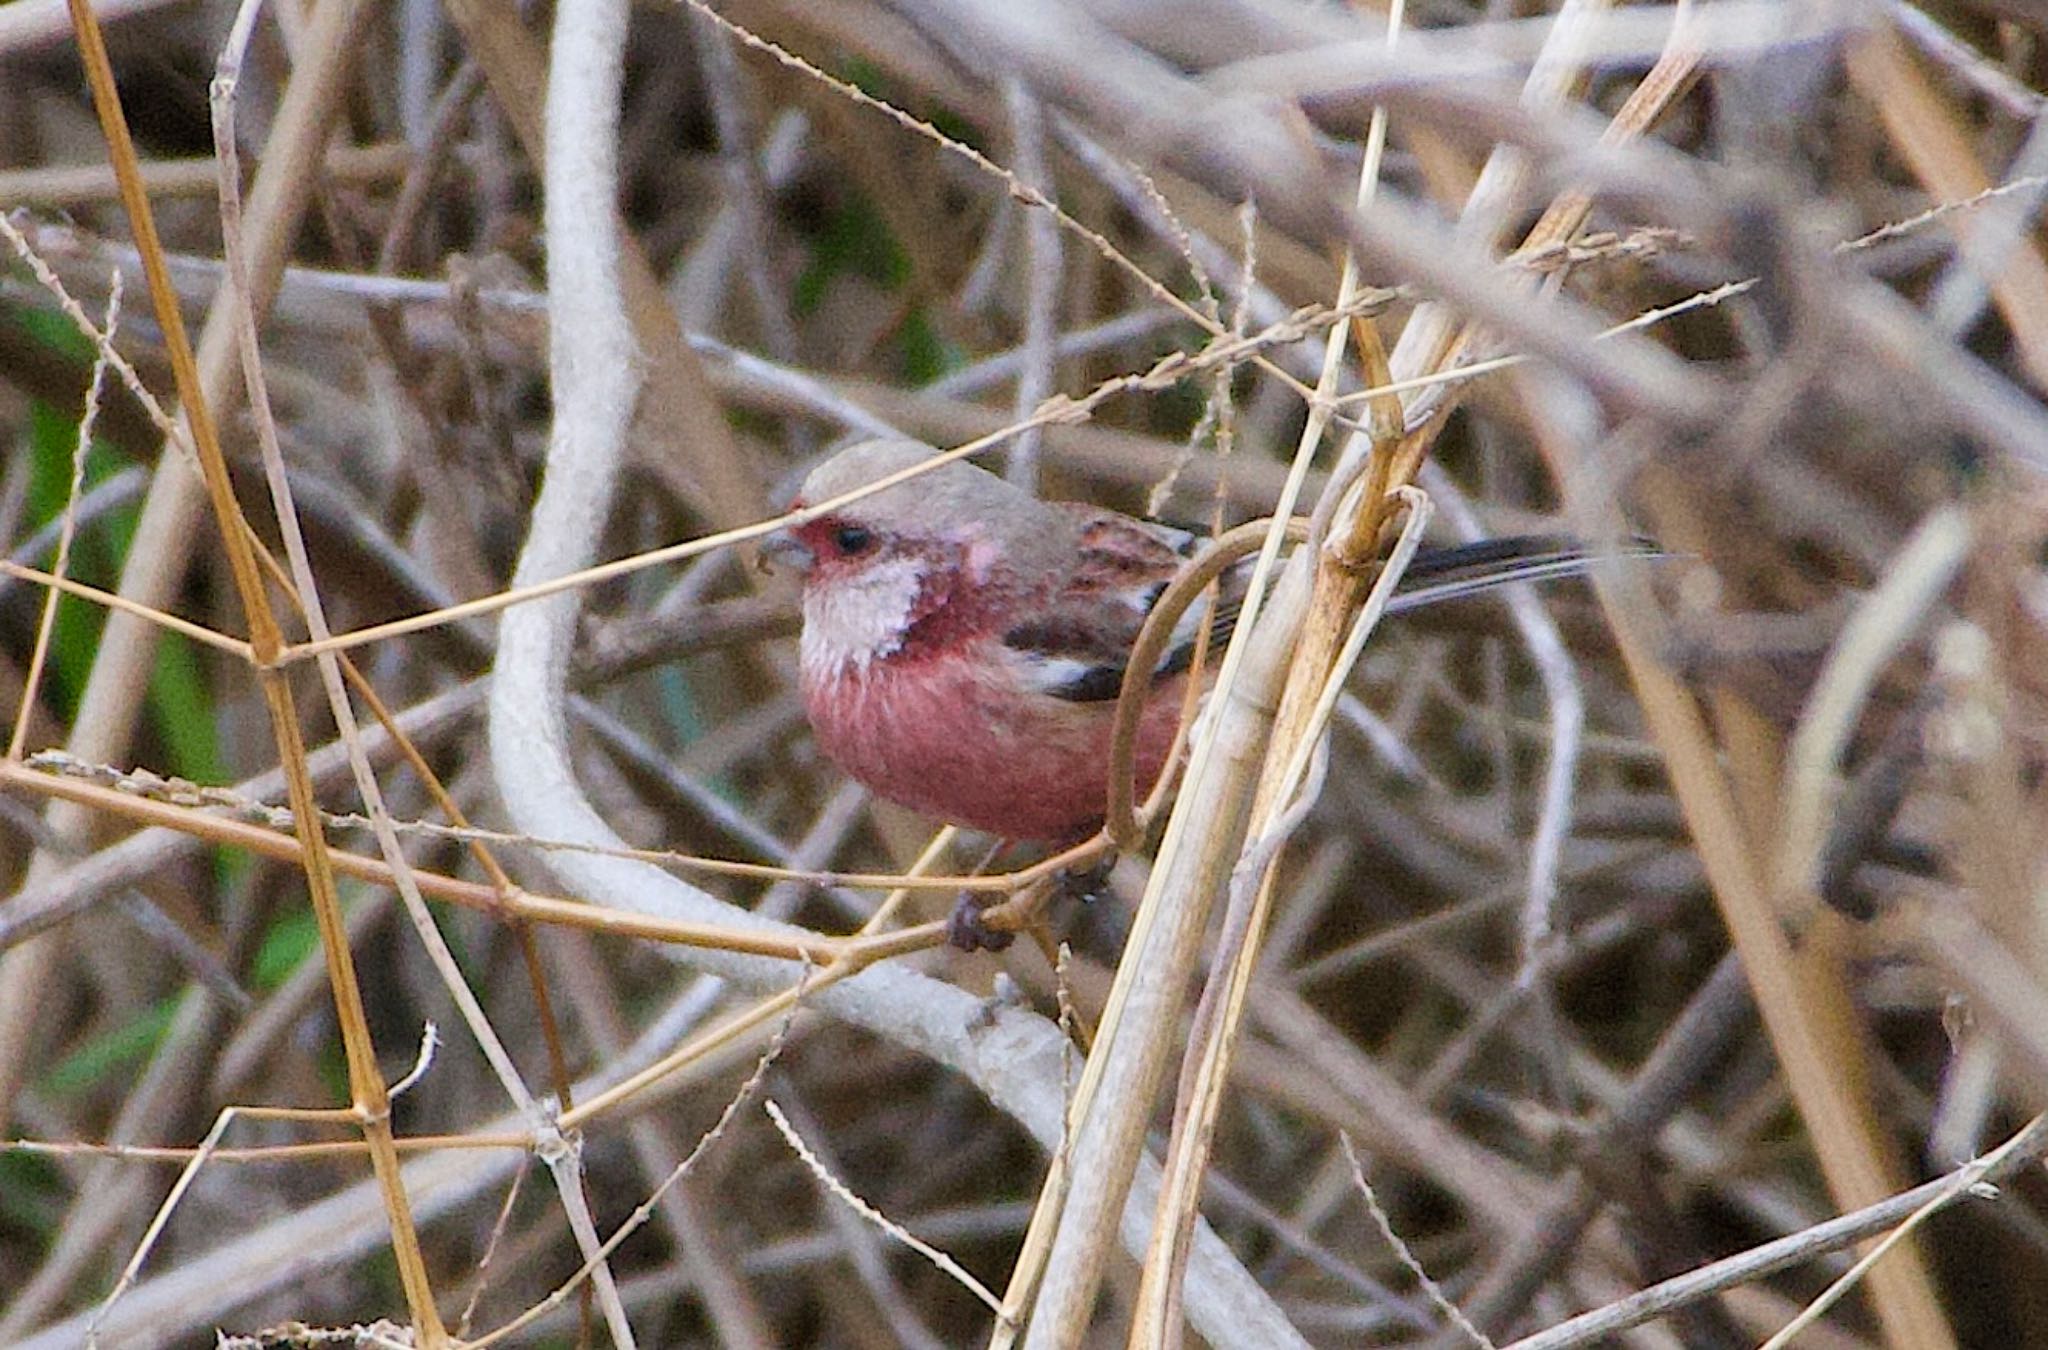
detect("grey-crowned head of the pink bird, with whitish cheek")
[762,440,1053,668]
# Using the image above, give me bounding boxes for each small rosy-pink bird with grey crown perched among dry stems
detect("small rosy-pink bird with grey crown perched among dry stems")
[762,438,1630,846]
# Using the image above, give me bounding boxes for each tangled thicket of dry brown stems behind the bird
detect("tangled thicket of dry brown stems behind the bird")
[0,0,2048,1346]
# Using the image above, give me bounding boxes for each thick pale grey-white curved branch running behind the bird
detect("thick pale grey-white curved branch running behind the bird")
[489,0,1300,1346]
